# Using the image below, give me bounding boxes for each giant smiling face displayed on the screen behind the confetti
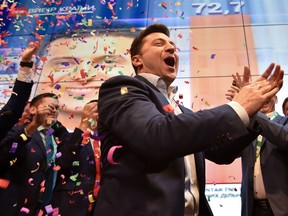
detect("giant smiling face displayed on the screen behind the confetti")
[36,35,133,113]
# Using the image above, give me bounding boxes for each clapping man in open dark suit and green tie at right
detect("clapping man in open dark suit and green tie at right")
[227,71,288,216]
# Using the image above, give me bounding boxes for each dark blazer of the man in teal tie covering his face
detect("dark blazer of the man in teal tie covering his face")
[0,123,68,215]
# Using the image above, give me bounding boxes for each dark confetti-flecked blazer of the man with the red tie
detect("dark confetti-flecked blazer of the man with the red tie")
[52,128,96,216]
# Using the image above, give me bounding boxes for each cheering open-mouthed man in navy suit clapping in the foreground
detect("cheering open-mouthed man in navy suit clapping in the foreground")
[94,24,283,216]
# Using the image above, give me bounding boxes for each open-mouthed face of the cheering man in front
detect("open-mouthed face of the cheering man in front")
[132,32,179,86]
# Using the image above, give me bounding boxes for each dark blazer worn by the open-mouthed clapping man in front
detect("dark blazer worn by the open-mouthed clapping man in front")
[94,76,255,216]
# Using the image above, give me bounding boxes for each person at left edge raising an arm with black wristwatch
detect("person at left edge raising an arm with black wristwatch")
[0,38,43,214]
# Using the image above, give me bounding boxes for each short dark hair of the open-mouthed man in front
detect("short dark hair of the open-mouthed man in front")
[130,23,170,73]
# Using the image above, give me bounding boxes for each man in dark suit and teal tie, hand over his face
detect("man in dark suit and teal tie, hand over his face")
[0,93,68,215]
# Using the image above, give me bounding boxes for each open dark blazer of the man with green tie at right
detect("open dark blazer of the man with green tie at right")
[241,114,288,216]
